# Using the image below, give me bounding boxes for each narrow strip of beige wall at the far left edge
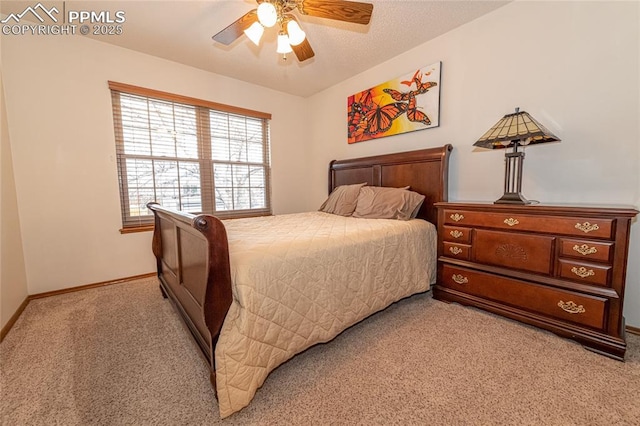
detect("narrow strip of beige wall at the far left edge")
[0,73,27,328]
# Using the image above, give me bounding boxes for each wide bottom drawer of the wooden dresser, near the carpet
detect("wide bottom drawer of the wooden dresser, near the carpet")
[439,264,608,330]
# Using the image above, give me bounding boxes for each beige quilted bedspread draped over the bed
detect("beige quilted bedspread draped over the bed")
[215,212,436,418]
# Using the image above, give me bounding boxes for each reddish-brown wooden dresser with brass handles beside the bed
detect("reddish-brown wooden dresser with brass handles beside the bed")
[433,203,638,360]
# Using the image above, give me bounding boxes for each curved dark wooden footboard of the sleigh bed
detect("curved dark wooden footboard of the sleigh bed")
[147,203,232,389]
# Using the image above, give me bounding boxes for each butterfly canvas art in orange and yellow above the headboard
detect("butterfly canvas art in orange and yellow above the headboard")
[347,62,441,143]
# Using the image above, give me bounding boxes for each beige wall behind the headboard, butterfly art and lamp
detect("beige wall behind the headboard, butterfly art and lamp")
[308,1,640,327]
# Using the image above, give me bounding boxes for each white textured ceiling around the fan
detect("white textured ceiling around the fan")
[2,0,510,97]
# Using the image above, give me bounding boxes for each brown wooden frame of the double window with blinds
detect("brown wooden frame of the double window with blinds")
[108,81,272,233]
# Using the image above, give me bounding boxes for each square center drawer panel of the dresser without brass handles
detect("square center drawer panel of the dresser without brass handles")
[473,229,555,274]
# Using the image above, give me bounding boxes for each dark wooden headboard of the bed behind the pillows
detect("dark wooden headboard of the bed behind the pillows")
[329,144,453,224]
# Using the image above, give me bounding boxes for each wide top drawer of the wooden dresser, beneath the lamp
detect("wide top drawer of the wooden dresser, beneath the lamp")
[444,209,615,238]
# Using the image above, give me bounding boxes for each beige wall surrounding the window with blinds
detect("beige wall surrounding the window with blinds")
[2,31,306,294]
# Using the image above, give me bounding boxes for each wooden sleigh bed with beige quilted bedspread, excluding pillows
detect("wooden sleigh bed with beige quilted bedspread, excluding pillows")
[148,145,452,418]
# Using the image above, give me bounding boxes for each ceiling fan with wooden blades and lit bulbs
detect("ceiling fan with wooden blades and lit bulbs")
[213,0,373,62]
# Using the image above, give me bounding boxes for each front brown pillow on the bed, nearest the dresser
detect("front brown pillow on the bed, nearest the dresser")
[353,186,425,220]
